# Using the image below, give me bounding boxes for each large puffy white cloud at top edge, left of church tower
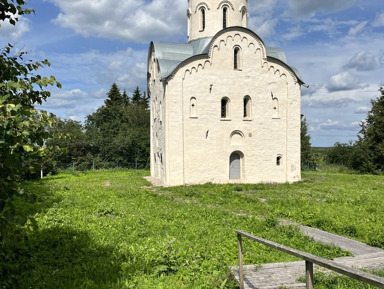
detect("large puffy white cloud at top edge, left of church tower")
[50,0,187,41]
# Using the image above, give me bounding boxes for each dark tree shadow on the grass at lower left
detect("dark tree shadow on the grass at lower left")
[17,227,124,288]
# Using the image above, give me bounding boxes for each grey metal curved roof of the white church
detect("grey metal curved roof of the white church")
[153,30,304,83]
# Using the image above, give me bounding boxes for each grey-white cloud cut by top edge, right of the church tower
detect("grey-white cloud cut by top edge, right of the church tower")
[288,0,356,17]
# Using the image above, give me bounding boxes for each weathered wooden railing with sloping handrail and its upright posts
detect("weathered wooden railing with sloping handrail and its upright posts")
[236,231,384,289]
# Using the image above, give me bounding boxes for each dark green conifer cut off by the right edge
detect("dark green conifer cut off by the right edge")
[352,87,384,173]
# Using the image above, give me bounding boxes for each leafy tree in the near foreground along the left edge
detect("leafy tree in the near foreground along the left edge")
[0,0,61,288]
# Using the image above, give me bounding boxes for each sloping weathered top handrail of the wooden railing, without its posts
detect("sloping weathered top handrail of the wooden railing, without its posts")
[236,231,384,288]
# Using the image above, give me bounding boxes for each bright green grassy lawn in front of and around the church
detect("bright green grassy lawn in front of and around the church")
[13,170,384,288]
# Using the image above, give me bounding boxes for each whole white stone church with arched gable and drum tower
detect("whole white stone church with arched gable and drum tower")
[148,0,304,186]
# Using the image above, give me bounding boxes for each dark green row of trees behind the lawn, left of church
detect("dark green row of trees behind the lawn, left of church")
[44,83,150,171]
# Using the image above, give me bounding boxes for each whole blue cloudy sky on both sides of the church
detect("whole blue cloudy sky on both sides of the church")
[0,0,384,146]
